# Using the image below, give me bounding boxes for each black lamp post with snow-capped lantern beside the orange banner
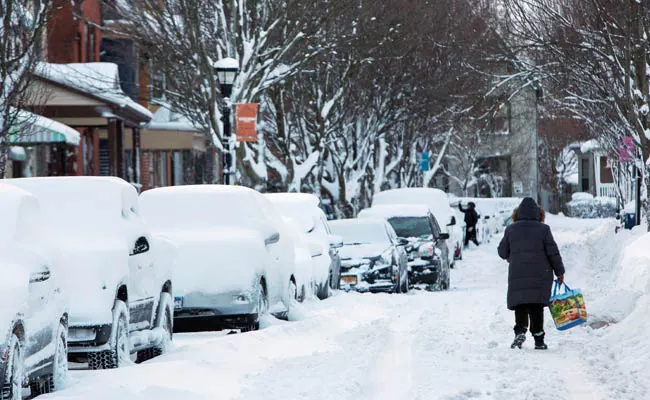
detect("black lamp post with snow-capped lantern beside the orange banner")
[214,57,239,185]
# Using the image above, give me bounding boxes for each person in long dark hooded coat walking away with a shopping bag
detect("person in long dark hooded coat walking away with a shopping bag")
[499,197,564,350]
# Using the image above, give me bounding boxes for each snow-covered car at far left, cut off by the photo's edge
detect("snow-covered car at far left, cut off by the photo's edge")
[0,183,68,400]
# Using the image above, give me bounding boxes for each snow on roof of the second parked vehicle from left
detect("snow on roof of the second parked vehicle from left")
[4,176,138,233]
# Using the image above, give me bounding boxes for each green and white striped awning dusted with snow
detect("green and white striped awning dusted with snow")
[9,110,79,146]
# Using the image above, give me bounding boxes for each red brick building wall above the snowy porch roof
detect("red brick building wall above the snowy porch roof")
[47,0,102,64]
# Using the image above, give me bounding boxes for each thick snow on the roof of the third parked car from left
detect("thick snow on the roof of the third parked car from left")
[140,185,262,231]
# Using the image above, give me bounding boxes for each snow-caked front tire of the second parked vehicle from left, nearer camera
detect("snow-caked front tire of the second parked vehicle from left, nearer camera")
[88,300,131,369]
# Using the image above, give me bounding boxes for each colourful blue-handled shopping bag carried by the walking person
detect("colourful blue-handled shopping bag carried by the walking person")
[549,281,587,331]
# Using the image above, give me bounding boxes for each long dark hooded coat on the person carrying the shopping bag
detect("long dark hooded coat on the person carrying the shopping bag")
[499,197,564,310]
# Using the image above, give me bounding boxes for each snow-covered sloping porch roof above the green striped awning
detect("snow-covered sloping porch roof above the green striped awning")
[35,62,153,121]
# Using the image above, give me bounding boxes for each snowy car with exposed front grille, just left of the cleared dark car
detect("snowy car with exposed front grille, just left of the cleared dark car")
[330,218,409,293]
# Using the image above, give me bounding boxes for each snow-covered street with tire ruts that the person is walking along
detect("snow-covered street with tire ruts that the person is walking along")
[46,216,649,400]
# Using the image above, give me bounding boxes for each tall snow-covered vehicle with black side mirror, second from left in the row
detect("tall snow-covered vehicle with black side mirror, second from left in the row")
[5,177,173,369]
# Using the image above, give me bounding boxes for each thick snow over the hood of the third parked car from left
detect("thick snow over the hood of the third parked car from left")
[155,228,270,296]
